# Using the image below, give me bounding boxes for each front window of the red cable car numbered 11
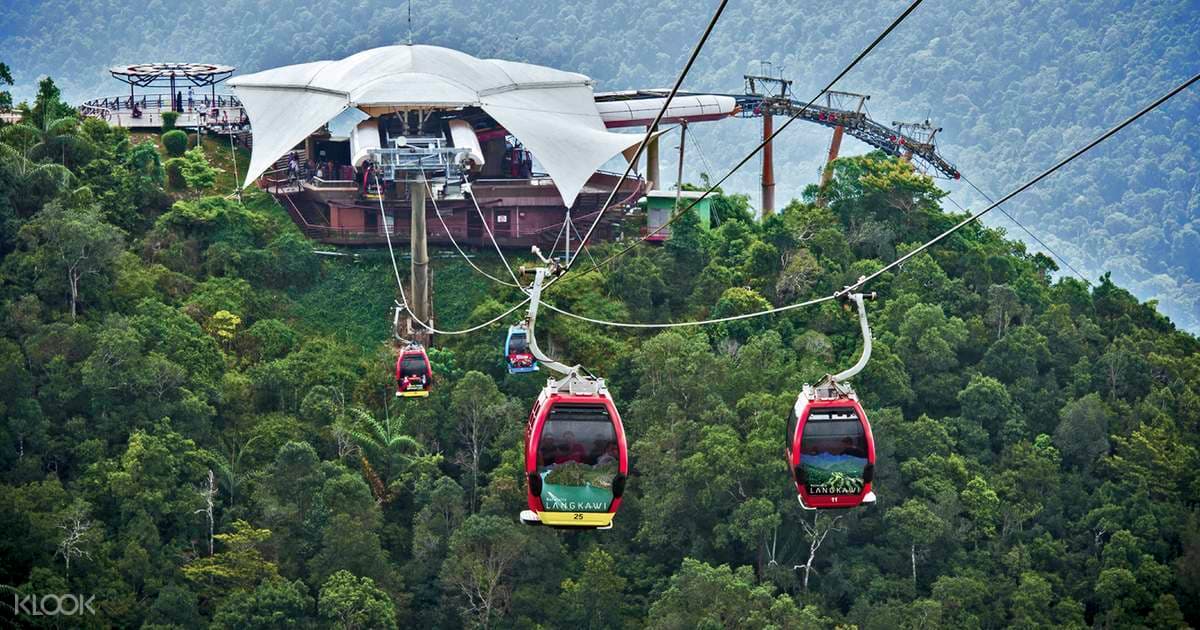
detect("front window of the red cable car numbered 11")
[800,408,868,494]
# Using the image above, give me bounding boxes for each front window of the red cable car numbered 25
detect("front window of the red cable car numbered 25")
[538,404,620,512]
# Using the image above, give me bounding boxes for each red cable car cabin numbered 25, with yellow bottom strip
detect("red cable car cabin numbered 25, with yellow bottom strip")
[521,386,629,529]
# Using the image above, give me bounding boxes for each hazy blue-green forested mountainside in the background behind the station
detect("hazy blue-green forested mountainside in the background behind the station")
[0,0,1200,332]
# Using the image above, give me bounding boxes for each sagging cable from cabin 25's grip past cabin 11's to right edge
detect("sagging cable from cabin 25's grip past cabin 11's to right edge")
[530,74,1200,329]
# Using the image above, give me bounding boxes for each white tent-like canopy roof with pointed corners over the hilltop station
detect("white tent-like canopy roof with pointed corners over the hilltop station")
[229,46,641,206]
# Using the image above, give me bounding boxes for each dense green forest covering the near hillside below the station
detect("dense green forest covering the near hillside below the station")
[0,71,1200,630]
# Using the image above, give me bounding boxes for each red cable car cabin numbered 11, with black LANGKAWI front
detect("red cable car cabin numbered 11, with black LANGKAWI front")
[786,385,875,509]
